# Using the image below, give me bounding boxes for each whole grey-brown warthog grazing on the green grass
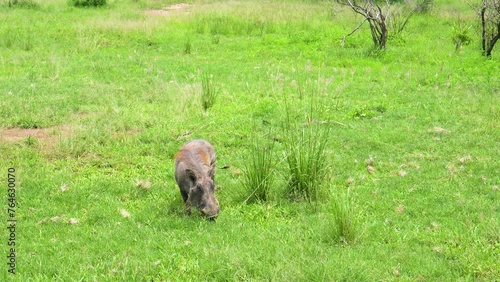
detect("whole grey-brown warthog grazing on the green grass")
[175,140,219,219]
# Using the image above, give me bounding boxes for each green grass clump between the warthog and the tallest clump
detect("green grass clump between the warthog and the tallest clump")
[243,137,275,202]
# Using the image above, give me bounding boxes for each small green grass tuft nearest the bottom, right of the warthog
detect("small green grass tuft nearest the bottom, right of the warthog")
[327,187,358,244]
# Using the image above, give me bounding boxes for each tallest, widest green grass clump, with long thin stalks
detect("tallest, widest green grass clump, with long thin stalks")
[285,87,329,202]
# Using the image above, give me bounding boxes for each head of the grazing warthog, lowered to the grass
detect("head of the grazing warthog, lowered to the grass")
[186,169,219,219]
